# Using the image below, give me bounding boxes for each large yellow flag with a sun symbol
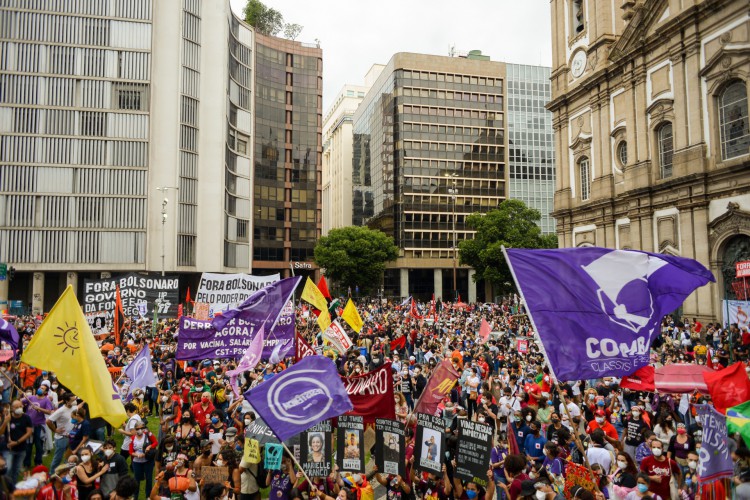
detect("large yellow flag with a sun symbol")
[21,285,127,427]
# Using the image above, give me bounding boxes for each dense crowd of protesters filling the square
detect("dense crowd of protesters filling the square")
[0,300,750,500]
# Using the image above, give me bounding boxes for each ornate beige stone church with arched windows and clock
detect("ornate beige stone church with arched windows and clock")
[548,0,750,319]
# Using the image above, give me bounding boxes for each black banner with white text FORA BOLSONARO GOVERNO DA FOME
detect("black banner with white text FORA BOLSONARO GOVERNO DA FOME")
[83,273,180,320]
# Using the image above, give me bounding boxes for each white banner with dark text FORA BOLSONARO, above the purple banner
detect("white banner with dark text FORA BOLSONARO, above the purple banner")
[195,273,281,313]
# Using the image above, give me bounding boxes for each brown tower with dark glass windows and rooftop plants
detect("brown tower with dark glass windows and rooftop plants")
[252,34,323,282]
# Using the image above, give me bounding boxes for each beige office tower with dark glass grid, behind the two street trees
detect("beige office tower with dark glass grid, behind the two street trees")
[353,51,507,301]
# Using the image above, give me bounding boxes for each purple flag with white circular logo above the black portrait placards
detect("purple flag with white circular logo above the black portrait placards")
[245,356,354,441]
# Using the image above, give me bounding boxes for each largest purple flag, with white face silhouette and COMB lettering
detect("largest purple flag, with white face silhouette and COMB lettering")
[506,247,714,380]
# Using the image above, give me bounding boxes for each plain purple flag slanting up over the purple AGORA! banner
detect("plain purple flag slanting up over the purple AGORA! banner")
[211,276,302,332]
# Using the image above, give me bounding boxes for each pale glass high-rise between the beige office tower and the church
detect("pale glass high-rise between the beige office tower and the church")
[505,64,555,233]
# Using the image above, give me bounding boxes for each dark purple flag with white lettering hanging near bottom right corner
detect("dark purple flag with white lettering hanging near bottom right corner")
[695,404,734,484]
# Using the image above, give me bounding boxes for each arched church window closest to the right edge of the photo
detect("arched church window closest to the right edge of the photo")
[719,81,750,160]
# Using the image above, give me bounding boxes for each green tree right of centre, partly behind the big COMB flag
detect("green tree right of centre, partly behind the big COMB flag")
[458,200,557,295]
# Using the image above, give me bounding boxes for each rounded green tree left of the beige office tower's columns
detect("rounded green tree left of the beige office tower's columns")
[315,226,398,293]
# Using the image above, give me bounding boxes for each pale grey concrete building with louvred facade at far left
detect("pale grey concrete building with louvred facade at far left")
[0,0,258,312]
